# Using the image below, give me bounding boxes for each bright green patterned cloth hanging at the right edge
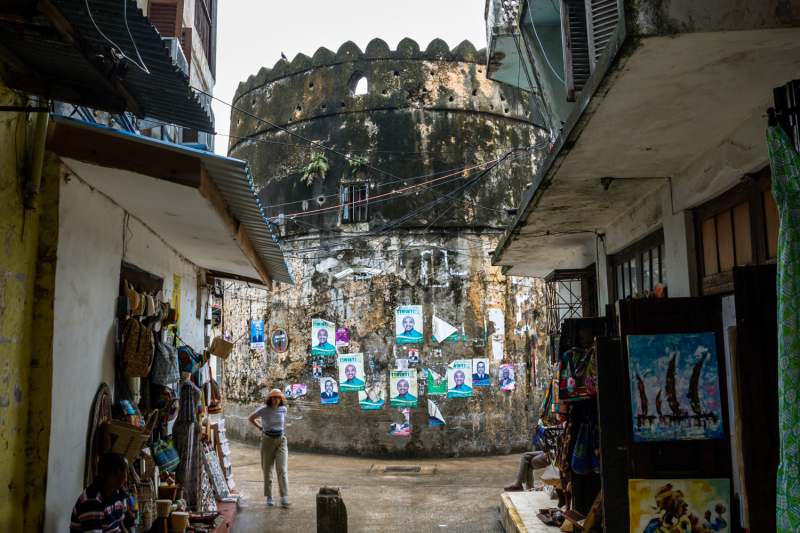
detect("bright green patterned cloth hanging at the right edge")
[767,126,800,533]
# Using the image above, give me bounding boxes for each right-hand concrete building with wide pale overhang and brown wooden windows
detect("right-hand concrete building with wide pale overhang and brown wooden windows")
[487,0,800,308]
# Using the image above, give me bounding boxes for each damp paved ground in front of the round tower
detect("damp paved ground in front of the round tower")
[230,442,520,533]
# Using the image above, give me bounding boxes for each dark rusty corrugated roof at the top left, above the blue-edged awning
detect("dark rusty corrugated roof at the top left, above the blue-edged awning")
[0,0,214,133]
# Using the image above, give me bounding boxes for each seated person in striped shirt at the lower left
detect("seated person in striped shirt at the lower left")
[69,452,136,533]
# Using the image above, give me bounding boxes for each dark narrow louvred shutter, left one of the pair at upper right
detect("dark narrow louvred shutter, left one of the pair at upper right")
[561,0,592,102]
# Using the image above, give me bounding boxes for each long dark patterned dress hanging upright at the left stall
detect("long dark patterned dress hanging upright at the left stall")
[172,380,203,511]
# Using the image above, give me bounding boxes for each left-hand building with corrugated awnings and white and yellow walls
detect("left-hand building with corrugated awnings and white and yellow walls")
[0,0,291,531]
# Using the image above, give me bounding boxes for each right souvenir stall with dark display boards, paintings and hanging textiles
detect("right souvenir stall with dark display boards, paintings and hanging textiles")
[539,286,777,533]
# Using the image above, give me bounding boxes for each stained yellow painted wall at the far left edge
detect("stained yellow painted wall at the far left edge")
[0,74,60,532]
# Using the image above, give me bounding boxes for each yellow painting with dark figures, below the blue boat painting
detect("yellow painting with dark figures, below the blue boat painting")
[628,479,731,533]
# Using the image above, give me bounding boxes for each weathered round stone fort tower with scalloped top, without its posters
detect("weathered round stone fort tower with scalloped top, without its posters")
[223,39,547,456]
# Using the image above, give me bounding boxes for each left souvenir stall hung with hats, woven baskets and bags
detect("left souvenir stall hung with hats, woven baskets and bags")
[86,263,238,533]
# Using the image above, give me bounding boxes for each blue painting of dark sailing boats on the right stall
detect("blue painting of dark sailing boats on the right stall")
[628,333,723,442]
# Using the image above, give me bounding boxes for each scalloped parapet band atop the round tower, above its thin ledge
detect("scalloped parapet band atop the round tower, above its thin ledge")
[231,38,541,143]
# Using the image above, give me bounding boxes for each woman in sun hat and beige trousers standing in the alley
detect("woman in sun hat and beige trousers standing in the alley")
[248,389,292,507]
